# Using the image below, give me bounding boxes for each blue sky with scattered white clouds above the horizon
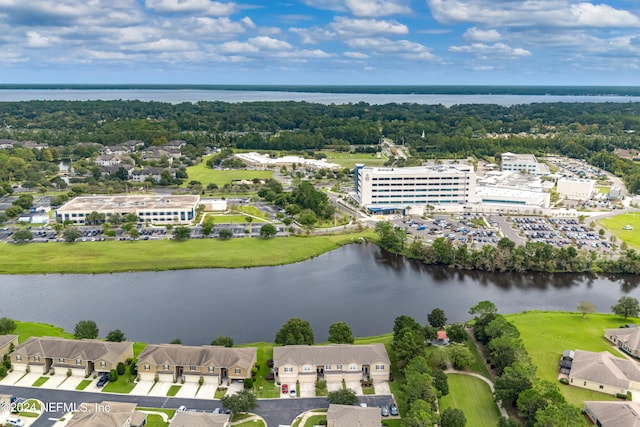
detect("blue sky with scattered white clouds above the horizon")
[0,0,640,85]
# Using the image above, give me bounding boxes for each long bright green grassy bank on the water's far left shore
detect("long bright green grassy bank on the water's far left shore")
[0,230,377,274]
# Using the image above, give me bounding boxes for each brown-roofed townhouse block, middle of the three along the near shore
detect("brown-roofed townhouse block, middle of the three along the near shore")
[138,344,257,384]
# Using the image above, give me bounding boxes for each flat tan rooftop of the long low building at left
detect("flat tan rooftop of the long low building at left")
[58,195,200,213]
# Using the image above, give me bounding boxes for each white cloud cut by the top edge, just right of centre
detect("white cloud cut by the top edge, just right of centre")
[303,0,411,17]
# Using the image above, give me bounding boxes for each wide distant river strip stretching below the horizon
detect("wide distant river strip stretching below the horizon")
[0,89,640,106]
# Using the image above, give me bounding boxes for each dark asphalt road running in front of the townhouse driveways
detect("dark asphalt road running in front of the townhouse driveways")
[0,386,392,427]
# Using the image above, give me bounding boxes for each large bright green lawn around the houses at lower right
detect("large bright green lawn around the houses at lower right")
[505,311,637,406]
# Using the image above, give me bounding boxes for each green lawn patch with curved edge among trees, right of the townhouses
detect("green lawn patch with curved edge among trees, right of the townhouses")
[439,374,500,427]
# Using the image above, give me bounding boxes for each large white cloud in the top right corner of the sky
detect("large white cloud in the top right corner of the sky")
[427,0,640,28]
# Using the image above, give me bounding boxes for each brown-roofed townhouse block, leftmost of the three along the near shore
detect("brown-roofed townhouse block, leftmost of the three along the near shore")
[10,337,133,376]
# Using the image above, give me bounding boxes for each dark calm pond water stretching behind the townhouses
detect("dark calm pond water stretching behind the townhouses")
[0,244,640,344]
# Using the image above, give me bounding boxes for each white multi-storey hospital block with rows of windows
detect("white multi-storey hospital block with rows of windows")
[355,164,476,212]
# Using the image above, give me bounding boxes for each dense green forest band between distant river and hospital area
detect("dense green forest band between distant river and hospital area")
[0,101,640,192]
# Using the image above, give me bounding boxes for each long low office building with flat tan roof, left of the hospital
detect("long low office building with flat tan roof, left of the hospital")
[56,195,200,224]
